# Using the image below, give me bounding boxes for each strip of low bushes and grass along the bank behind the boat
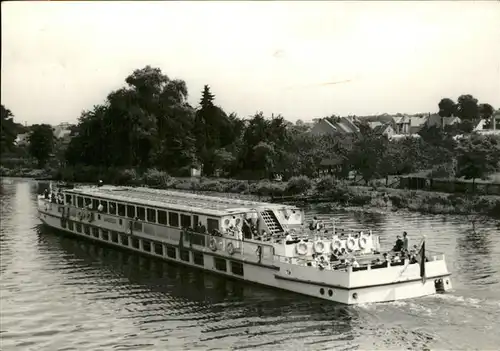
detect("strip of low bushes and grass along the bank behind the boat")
[12,167,492,218]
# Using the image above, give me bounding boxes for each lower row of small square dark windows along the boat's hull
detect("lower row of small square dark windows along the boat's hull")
[62,221,243,276]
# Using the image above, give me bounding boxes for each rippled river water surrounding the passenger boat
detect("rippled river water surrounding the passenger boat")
[0,179,500,351]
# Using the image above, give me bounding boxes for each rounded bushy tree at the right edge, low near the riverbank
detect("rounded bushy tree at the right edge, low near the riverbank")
[457,135,500,188]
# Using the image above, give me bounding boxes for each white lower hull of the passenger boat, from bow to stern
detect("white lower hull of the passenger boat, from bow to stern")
[39,209,452,304]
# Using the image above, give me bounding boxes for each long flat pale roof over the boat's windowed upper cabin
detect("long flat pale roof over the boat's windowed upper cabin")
[65,186,297,216]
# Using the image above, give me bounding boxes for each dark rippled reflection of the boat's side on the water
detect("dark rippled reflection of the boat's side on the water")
[38,227,357,347]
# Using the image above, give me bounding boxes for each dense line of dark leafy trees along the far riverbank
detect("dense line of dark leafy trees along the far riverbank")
[2,66,500,187]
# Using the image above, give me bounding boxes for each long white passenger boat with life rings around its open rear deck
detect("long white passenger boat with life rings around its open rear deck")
[38,185,452,304]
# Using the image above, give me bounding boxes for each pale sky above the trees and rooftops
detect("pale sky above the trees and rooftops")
[1,1,500,124]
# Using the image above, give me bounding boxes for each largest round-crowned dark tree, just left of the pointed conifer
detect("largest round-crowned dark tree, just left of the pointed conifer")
[66,66,195,173]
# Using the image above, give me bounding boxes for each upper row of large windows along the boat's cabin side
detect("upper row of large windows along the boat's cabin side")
[66,194,219,233]
